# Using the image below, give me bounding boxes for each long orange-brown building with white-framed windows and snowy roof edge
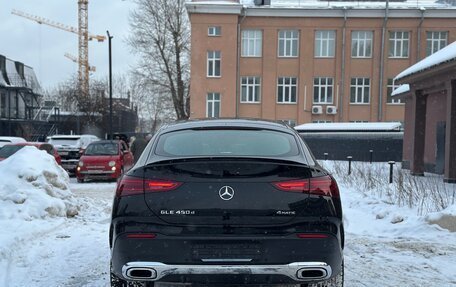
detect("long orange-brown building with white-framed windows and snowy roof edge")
[186,0,456,124]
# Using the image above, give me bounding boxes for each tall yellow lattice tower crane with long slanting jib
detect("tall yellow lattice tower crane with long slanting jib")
[11,0,106,97]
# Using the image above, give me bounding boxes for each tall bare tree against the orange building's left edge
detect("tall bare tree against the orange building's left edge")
[128,0,190,119]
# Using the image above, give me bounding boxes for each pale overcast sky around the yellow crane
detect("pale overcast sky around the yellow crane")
[0,0,136,88]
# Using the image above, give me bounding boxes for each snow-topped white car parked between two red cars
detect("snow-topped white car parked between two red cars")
[48,135,100,173]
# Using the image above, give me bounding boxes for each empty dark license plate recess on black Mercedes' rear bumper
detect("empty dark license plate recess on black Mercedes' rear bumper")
[192,242,263,260]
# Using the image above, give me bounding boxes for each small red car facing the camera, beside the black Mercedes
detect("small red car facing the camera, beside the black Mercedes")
[76,140,133,182]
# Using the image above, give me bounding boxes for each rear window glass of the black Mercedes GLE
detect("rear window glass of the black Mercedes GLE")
[155,130,299,157]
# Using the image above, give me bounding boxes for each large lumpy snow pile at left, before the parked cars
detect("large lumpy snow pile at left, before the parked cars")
[0,146,78,220]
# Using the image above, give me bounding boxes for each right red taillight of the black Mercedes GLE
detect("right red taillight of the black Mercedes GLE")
[273,175,339,197]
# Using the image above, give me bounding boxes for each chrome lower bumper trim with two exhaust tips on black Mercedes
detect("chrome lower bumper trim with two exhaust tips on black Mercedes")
[122,262,332,282]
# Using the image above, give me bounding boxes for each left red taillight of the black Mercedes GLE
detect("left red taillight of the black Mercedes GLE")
[116,176,182,197]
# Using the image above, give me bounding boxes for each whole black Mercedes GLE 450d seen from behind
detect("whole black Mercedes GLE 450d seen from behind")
[109,119,344,287]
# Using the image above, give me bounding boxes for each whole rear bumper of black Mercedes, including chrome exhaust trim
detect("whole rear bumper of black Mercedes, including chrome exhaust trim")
[111,233,342,284]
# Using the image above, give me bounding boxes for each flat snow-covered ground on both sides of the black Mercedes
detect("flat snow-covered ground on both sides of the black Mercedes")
[0,153,456,287]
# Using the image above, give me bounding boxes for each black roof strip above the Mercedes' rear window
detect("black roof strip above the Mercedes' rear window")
[161,118,292,132]
